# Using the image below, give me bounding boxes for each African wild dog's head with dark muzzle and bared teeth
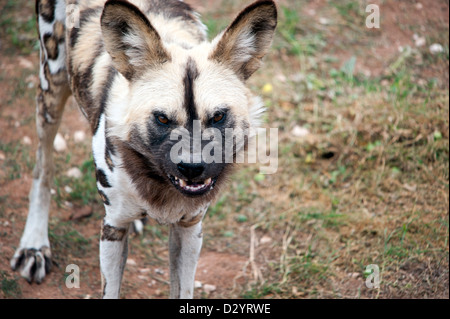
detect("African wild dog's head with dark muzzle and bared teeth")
[101,1,277,205]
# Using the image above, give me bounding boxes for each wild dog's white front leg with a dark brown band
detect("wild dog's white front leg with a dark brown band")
[100,221,130,299]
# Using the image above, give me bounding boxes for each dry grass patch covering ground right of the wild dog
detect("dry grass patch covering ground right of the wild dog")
[201,1,449,298]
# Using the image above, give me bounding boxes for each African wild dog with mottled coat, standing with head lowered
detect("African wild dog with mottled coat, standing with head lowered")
[11,0,277,298]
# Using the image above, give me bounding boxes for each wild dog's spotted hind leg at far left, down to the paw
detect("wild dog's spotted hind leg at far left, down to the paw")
[11,0,70,283]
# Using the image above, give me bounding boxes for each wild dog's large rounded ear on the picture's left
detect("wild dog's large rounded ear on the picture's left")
[101,0,170,81]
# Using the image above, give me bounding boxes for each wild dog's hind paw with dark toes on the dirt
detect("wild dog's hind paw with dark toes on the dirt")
[11,246,52,284]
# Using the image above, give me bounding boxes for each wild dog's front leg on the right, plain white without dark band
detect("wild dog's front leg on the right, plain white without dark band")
[169,221,203,299]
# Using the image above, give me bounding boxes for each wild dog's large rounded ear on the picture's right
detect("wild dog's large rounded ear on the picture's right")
[210,0,277,81]
